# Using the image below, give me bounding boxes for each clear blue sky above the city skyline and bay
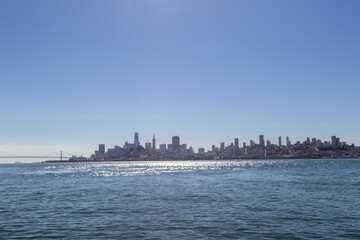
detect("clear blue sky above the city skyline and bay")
[0,0,360,163]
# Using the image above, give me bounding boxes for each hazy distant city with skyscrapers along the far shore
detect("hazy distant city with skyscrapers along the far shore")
[51,132,360,162]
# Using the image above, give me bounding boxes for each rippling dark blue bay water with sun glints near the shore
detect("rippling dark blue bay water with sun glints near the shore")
[0,160,360,239]
